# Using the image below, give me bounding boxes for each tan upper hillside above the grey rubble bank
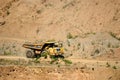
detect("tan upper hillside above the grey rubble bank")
[0,0,120,40]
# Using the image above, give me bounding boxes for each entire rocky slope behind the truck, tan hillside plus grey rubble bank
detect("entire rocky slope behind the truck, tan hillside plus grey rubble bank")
[0,0,120,58]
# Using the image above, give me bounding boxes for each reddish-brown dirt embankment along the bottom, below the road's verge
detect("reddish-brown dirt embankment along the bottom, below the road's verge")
[0,66,120,80]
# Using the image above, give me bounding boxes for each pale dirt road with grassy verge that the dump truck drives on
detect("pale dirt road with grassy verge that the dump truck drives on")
[0,56,120,68]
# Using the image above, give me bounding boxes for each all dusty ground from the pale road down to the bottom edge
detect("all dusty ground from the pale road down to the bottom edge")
[0,56,120,80]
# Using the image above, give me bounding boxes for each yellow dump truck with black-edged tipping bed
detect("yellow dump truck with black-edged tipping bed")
[23,42,64,58]
